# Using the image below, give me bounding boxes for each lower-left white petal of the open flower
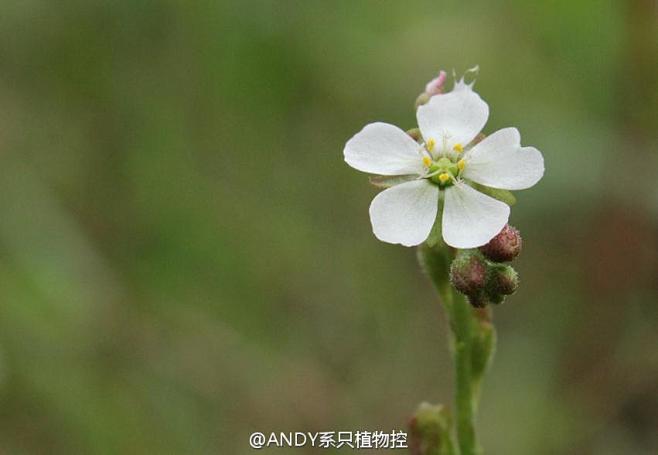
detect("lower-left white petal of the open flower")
[370,179,439,246]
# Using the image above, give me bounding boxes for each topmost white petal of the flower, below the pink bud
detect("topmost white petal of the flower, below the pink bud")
[416,89,489,148]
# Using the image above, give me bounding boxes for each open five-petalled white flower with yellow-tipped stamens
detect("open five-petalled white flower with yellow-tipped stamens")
[344,85,544,248]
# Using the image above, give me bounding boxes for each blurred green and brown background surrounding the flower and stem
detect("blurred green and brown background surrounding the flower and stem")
[0,0,658,455]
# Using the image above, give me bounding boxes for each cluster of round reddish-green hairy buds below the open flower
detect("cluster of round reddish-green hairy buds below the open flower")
[450,225,522,308]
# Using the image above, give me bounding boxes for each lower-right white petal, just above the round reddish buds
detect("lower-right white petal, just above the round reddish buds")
[441,182,509,248]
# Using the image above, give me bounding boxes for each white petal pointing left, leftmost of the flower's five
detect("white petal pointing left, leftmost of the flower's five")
[343,122,423,175]
